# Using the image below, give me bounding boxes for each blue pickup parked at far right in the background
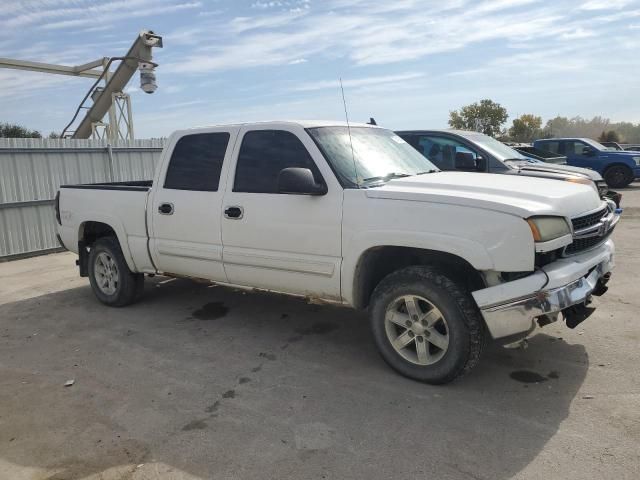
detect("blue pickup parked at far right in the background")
[533,138,640,188]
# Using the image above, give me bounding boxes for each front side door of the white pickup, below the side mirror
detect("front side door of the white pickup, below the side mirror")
[222,124,343,299]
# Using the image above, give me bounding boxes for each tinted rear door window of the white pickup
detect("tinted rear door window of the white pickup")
[164,132,230,192]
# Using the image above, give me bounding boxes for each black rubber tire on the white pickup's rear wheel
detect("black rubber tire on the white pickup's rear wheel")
[88,237,144,307]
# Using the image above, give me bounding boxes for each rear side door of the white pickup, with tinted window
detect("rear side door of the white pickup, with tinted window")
[148,128,237,282]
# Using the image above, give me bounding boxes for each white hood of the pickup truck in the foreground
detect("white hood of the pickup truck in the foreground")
[366,172,602,218]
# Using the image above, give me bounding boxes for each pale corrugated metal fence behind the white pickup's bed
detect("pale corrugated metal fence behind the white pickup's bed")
[0,138,164,261]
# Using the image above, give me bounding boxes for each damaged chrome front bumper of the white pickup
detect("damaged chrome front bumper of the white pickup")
[473,241,613,338]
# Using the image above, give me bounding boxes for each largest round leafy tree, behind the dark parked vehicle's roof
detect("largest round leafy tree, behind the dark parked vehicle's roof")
[449,99,509,137]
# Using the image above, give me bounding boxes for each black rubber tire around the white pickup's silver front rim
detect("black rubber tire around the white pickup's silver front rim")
[370,266,485,385]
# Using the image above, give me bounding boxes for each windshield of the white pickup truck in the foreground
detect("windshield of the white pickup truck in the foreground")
[307,127,438,187]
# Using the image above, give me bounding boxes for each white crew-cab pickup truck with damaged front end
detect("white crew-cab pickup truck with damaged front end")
[56,121,619,383]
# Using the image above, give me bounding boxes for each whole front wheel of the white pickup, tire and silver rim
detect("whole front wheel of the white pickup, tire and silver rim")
[371,267,485,384]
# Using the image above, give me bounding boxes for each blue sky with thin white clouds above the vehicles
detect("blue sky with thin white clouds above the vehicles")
[0,0,640,138]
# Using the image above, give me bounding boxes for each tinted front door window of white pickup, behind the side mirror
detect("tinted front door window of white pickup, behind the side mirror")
[233,130,322,193]
